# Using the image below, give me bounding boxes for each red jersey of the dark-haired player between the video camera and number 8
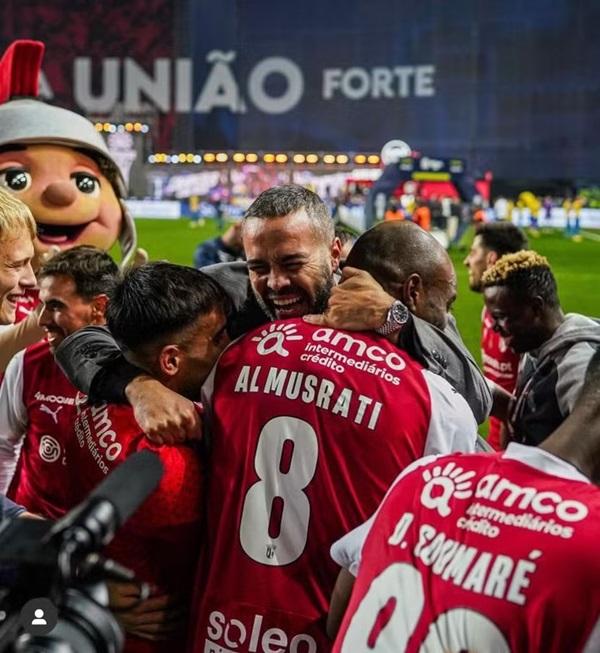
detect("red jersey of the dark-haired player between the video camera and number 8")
[67,404,203,653]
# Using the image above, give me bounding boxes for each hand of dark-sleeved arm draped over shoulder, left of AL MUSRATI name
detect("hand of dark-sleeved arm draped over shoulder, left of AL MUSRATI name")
[125,374,202,445]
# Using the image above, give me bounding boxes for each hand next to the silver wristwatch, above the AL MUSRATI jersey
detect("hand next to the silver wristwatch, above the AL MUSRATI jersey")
[304,267,395,331]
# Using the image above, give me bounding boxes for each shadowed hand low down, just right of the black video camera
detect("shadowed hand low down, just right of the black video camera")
[107,581,185,640]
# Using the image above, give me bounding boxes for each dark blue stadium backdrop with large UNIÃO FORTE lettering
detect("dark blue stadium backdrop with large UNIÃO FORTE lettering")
[0,0,600,180]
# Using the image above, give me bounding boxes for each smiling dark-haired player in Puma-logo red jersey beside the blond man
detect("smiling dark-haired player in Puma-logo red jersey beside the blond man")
[0,246,119,519]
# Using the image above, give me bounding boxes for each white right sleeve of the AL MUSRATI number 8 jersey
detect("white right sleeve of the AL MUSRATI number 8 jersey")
[423,370,477,456]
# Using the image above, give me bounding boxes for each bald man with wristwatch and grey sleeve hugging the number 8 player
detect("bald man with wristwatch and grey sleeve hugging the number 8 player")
[305,221,485,422]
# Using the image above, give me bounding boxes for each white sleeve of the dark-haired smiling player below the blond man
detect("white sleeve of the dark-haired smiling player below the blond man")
[0,351,27,494]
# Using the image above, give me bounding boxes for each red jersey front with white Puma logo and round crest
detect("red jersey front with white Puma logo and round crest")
[2,340,77,519]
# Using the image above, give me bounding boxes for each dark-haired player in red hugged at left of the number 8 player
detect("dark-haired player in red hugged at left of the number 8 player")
[67,262,230,653]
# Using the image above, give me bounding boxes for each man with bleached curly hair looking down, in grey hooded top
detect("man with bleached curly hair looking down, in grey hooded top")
[481,251,600,445]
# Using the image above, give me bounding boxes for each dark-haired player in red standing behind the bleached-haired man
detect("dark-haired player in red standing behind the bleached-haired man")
[464,222,527,449]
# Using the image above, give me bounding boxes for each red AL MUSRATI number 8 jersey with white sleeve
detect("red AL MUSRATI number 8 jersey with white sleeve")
[193,320,476,653]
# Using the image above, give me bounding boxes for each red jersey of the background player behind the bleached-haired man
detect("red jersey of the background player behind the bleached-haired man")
[481,308,521,449]
